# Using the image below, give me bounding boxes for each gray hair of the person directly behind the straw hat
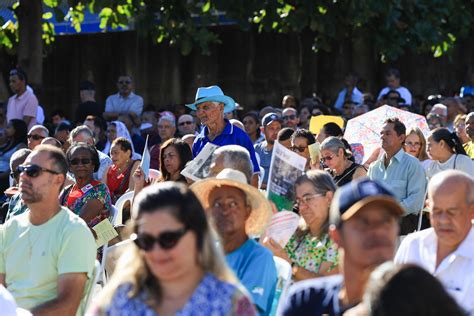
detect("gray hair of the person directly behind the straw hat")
[211,145,253,183]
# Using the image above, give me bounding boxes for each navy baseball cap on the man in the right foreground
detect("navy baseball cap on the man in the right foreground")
[329,178,405,226]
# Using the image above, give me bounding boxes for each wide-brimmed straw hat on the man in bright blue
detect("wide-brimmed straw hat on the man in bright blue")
[190,168,273,236]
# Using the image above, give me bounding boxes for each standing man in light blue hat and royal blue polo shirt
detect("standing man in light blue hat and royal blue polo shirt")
[186,86,260,186]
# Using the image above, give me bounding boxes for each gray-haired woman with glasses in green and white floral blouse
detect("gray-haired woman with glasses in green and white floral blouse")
[263,170,338,281]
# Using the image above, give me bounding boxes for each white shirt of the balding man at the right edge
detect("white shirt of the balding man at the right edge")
[395,226,474,315]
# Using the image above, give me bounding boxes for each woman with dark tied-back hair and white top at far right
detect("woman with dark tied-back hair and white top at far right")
[426,128,474,179]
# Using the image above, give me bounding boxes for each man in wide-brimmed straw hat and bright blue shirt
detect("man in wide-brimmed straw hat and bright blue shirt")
[191,169,277,315]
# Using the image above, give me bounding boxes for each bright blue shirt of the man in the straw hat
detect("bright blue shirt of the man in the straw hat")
[226,239,277,315]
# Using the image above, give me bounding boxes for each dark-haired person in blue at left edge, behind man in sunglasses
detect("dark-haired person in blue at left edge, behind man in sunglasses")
[0,119,28,192]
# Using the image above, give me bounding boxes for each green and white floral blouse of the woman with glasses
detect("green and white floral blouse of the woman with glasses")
[285,231,338,272]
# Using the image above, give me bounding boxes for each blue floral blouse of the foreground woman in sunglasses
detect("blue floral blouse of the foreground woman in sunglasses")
[97,273,256,316]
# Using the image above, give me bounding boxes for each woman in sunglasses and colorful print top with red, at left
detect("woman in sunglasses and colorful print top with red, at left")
[60,143,112,227]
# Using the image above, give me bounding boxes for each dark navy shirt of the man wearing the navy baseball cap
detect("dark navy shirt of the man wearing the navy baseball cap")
[278,275,353,316]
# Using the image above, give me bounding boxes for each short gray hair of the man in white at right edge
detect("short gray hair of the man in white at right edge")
[428,170,474,205]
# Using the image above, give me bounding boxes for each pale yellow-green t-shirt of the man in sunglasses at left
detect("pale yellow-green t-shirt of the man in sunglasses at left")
[0,207,97,314]
